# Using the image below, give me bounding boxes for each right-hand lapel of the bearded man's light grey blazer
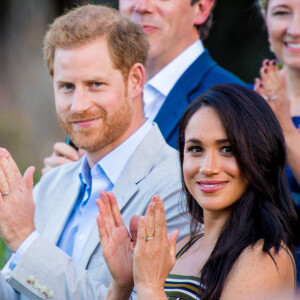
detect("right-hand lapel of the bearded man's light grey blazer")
[80,124,166,268]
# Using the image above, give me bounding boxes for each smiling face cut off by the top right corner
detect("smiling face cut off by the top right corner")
[266,0,300,68]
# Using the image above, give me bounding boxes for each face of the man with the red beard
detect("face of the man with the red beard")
[53,38,133,153]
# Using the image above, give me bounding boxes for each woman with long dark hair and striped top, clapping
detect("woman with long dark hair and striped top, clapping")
[97,84,298,300]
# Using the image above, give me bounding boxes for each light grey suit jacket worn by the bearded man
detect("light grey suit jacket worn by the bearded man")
[0,125,189,300]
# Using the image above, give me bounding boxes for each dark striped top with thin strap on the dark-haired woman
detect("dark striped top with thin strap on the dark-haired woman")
[164,233,204,300]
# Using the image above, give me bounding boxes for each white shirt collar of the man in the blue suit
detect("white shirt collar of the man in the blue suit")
[145,40,204,97]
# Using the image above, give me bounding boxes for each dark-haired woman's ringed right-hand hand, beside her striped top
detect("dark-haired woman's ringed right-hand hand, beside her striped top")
[133,196,179,300]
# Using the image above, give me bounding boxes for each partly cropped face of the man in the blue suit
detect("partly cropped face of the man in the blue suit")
[119,0,203,66]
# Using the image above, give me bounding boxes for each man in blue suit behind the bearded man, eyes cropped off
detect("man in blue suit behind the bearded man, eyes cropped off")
[43,0,243,173]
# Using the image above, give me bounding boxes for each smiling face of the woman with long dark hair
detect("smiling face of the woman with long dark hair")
[183,107,248,217]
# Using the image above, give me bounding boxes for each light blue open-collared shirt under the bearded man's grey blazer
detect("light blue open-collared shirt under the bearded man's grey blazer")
[57,121,152,264]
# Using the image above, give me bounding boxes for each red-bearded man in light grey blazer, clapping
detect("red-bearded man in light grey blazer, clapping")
[0,5,189,300]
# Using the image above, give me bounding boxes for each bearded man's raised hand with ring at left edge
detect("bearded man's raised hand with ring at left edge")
[0,148,35,252]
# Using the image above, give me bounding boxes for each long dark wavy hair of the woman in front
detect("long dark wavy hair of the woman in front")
[179,84,299,300]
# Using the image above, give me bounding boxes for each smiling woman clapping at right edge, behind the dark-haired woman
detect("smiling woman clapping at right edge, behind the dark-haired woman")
[255,0,300,206]
